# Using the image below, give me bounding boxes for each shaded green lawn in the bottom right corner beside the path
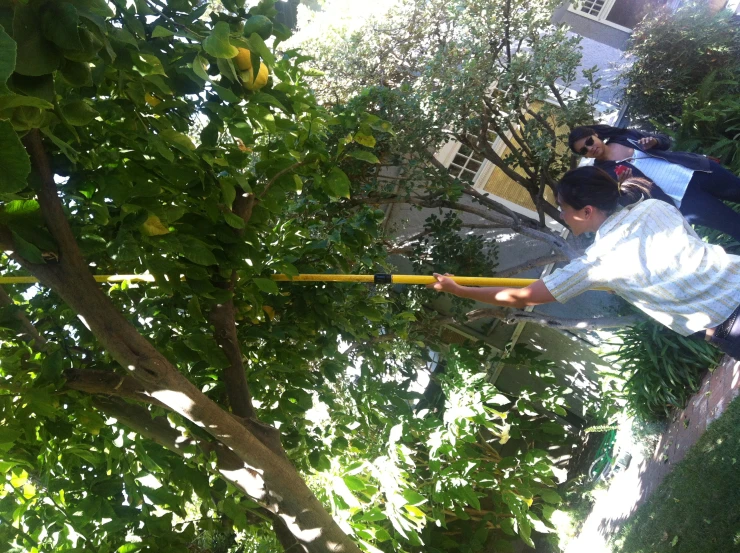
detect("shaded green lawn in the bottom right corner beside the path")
[613,394,740,553]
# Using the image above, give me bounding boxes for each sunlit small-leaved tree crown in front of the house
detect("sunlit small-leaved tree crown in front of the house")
[304,0,599,226]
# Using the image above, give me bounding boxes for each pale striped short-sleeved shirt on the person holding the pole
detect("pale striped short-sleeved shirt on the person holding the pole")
[543,200,740,336]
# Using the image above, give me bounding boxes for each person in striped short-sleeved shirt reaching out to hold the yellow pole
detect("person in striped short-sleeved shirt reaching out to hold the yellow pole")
[429,167,740,359]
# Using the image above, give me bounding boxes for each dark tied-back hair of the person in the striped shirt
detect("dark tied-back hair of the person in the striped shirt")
[557,165,654,213]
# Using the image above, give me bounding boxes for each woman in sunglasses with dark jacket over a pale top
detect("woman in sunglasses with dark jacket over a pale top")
[568,125,740,242]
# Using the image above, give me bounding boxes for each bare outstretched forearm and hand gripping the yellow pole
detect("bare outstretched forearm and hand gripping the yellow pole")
[428,273,557,308]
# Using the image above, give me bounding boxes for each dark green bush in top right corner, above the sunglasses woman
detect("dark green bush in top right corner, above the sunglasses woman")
[622,2,740,126]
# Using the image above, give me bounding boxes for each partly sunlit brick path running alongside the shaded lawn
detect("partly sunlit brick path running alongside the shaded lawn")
[566,356,740,553]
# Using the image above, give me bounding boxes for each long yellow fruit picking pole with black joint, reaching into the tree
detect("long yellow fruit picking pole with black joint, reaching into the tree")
[0,273,536,288]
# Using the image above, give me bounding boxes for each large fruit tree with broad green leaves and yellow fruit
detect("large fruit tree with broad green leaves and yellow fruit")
[0,0,580,553]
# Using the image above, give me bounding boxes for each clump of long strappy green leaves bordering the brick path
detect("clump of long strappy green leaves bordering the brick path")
[606,321,721,421]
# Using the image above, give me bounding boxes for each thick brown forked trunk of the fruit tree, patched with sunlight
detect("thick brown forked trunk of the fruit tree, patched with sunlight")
[14,130,360,553]
